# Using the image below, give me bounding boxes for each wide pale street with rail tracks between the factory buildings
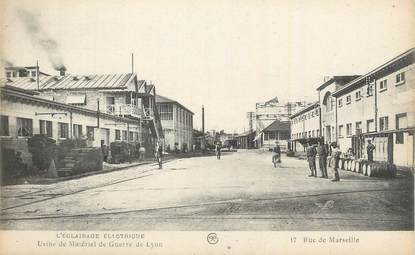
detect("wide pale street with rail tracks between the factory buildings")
[0,151,414,230]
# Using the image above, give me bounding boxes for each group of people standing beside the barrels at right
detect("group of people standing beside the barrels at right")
[306,140,375,182]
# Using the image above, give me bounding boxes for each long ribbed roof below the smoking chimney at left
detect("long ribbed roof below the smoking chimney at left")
[6,73,135,90]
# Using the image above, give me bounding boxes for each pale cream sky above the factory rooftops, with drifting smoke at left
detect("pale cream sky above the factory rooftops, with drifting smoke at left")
[0,0,415,132]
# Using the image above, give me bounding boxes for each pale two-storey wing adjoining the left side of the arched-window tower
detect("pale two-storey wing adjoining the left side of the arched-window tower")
[290,102,321,151]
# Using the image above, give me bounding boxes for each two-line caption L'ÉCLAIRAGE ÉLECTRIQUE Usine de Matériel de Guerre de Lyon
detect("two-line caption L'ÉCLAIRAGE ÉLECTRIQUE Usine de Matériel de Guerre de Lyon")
[36,232,163,249]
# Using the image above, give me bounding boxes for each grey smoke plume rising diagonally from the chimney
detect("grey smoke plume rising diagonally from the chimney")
[17,9,66,71]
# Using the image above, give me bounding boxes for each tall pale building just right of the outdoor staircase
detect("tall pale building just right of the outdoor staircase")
[156,95,194,151]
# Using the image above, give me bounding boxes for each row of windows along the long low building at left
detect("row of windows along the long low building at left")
[0,115,140,141]
